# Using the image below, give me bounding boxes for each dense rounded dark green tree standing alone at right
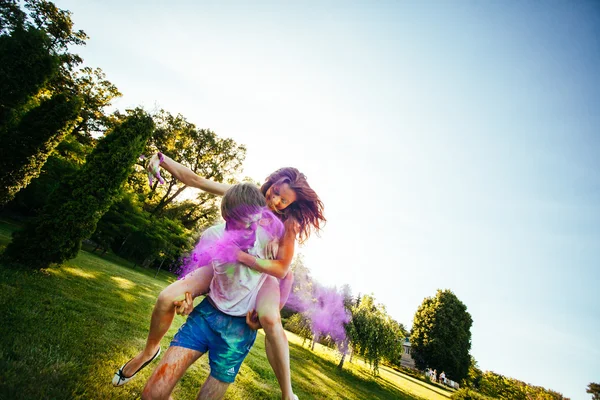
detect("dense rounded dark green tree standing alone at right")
[410,290,473,381]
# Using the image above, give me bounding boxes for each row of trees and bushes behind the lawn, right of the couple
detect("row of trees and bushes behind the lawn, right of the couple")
[282,255,566,400]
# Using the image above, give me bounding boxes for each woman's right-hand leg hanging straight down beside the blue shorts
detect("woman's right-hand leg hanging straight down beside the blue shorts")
[256,276,294,399]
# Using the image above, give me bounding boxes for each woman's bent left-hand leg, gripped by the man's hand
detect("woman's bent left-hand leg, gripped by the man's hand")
[123,266,214,377]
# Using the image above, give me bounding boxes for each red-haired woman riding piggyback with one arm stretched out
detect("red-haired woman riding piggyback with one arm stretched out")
[113,153,325,399]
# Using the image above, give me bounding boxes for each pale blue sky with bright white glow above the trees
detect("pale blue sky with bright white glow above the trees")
[56,0,600,399]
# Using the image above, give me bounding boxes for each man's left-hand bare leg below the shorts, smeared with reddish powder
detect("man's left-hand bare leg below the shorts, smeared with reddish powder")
[142,346,203,400]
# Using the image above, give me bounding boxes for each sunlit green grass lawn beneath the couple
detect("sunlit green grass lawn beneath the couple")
[0,223,449,400]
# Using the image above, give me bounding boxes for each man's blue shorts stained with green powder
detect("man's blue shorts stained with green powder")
[171,297,256,383]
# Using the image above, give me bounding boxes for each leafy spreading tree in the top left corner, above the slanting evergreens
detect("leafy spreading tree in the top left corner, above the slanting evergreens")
[0,0,121,143]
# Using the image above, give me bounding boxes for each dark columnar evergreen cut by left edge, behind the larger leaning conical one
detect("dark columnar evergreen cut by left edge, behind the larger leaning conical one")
[0,94,81,206]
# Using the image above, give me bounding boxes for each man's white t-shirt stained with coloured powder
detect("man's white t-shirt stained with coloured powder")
[202,224,277,317]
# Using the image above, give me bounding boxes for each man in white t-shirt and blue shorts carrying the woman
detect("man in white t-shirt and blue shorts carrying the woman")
[142,184,281,399]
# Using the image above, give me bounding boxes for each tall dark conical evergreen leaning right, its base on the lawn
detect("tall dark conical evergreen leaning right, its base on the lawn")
[4,109,154,268]
